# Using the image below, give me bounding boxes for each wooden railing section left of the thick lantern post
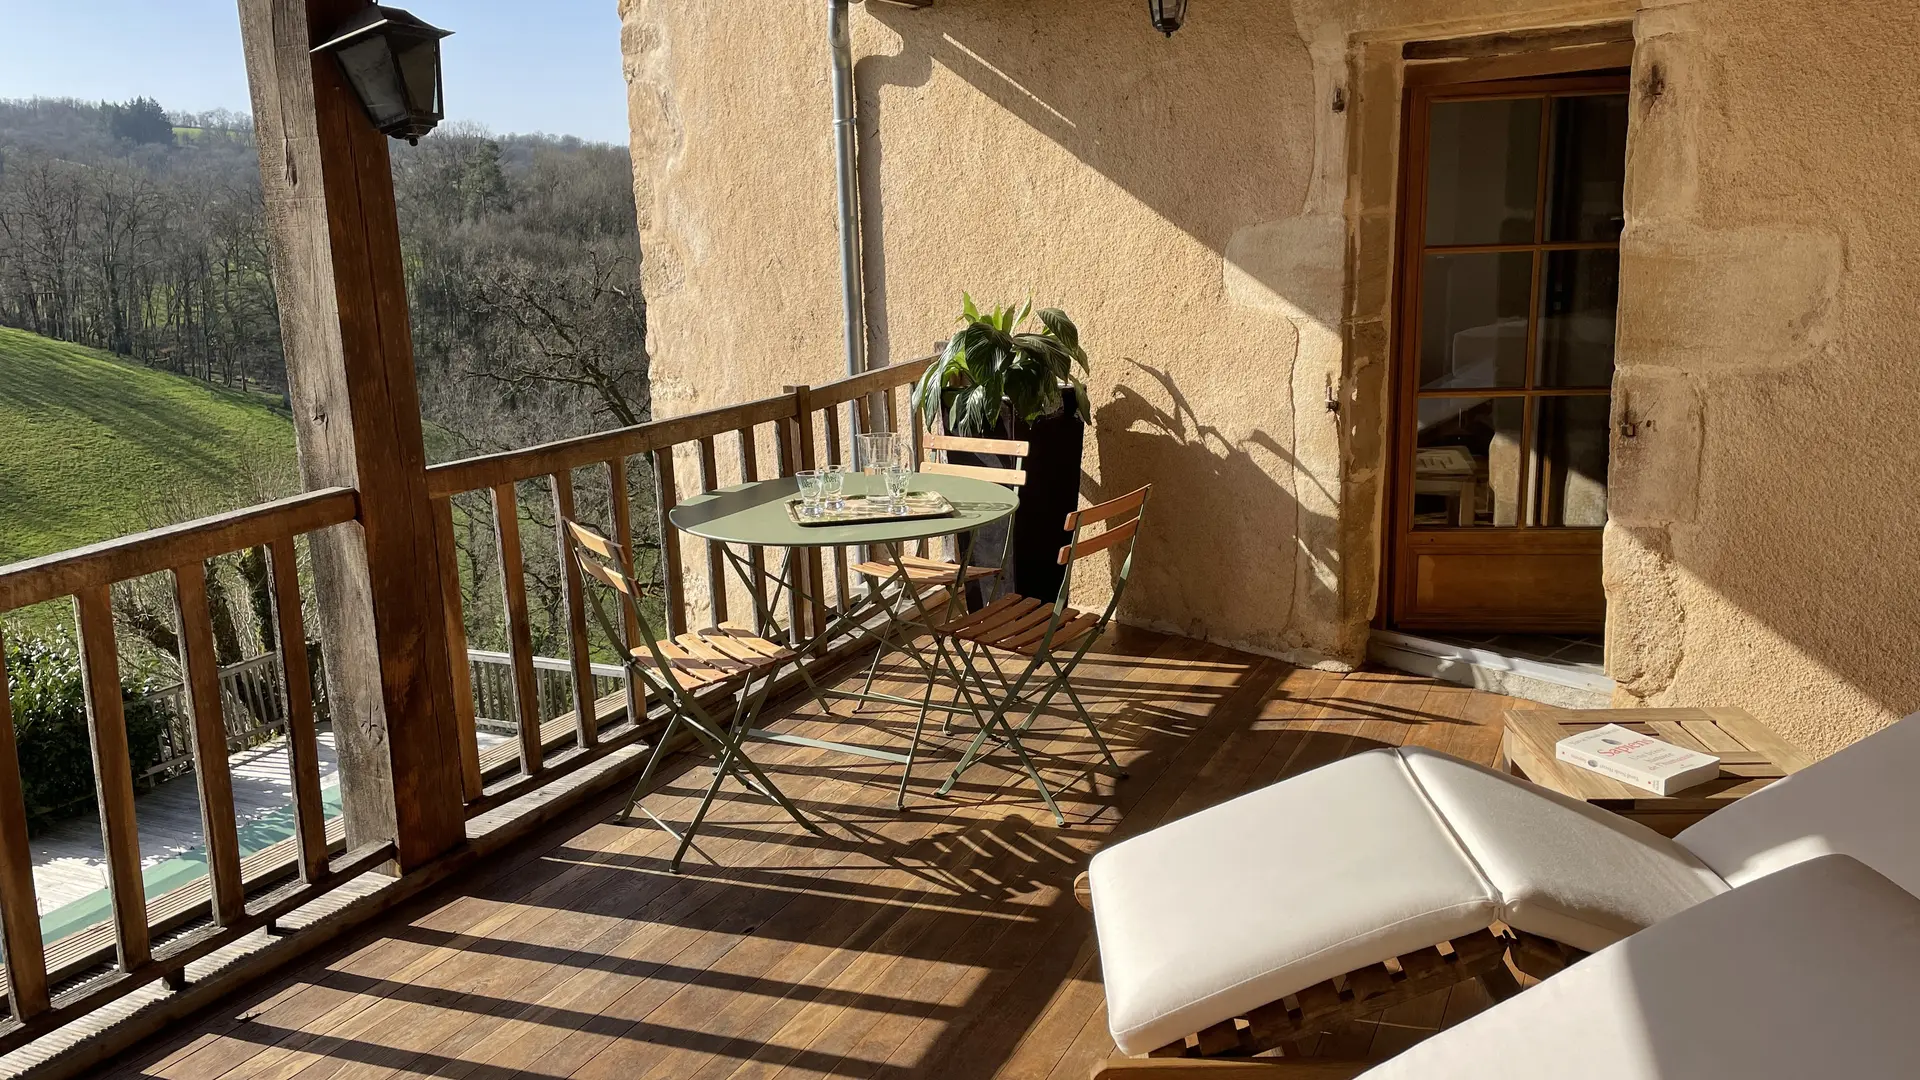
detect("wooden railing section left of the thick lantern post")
[0,488,392,1051]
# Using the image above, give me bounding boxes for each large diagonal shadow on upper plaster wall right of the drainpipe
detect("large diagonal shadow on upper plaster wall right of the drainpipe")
[854,0,1338,357]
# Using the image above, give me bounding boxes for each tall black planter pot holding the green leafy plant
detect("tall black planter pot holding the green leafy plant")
[948,394,1087,605]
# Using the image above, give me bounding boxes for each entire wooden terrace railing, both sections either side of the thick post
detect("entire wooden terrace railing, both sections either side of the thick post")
[0,351,929,1053]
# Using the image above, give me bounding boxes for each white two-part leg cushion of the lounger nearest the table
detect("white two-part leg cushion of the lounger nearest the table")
[1089,748,1726,1053]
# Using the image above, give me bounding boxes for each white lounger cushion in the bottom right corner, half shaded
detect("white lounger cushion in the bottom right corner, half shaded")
[1363,855,1920,1080]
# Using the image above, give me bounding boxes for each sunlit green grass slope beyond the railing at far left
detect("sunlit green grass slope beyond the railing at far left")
[0,327,294,565]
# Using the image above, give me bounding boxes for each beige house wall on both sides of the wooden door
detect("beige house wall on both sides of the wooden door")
[622,0,1920,749]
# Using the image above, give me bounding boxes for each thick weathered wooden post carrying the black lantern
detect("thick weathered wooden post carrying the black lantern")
[240,0,467,871]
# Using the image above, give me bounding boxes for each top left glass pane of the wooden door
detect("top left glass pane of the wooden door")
[1427,98,1544,244]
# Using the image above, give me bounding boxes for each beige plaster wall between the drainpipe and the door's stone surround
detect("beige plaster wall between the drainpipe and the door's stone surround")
[856,0,1342,659]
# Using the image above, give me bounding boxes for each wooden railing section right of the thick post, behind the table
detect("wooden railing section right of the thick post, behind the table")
[426,357,931,817]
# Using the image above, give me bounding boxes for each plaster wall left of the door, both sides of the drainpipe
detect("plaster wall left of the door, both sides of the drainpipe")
[622,0,1620,663]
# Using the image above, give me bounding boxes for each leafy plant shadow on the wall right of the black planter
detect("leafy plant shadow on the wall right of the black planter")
[1081,359,1338,653]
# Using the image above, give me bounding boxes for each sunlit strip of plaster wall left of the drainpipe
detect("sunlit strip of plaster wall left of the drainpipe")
[620,0,847,417]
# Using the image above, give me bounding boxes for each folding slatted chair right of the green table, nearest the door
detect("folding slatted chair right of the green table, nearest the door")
[922,484,1152,824]
